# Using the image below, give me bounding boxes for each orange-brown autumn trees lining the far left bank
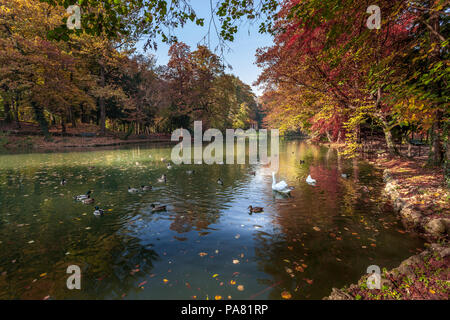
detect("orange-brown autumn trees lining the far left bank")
[0,0,261,137]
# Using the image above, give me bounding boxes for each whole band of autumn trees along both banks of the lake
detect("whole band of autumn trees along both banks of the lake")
[0,0,450,172]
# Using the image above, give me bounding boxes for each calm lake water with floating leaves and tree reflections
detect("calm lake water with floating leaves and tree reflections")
[0,141,423,299]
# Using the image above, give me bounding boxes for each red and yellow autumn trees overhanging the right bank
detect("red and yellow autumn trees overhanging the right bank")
[257,0,450,165]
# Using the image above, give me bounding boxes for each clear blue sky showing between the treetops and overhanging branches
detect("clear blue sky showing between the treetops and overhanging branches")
[134,0,273,95]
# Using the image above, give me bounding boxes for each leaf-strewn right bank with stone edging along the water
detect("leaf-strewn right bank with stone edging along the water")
[323,144,450,300]
